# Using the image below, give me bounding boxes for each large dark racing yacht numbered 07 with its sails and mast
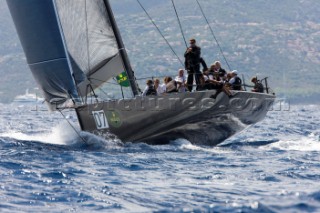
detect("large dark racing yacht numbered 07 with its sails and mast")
[7,0,275,146]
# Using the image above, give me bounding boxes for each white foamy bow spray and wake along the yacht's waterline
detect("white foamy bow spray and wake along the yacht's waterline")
[0,121,320,153]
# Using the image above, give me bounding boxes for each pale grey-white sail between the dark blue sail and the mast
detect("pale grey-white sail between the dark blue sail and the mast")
[55,0,135,96]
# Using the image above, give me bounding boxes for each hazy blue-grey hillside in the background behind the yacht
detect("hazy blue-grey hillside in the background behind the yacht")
[0,0,320,102]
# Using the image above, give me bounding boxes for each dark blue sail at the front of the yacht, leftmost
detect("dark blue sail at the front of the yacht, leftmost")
[7,0,78,109]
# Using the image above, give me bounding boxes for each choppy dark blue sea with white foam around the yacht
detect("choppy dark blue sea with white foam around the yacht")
[0,104,320,213]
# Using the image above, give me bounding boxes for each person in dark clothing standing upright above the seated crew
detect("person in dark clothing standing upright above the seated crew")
[184,38,202,92]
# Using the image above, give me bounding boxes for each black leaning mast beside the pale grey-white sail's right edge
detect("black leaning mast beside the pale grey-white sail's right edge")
[103,0,139,96]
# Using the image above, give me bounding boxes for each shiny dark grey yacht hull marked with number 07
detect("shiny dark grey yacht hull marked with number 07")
[76,91,275,146]
